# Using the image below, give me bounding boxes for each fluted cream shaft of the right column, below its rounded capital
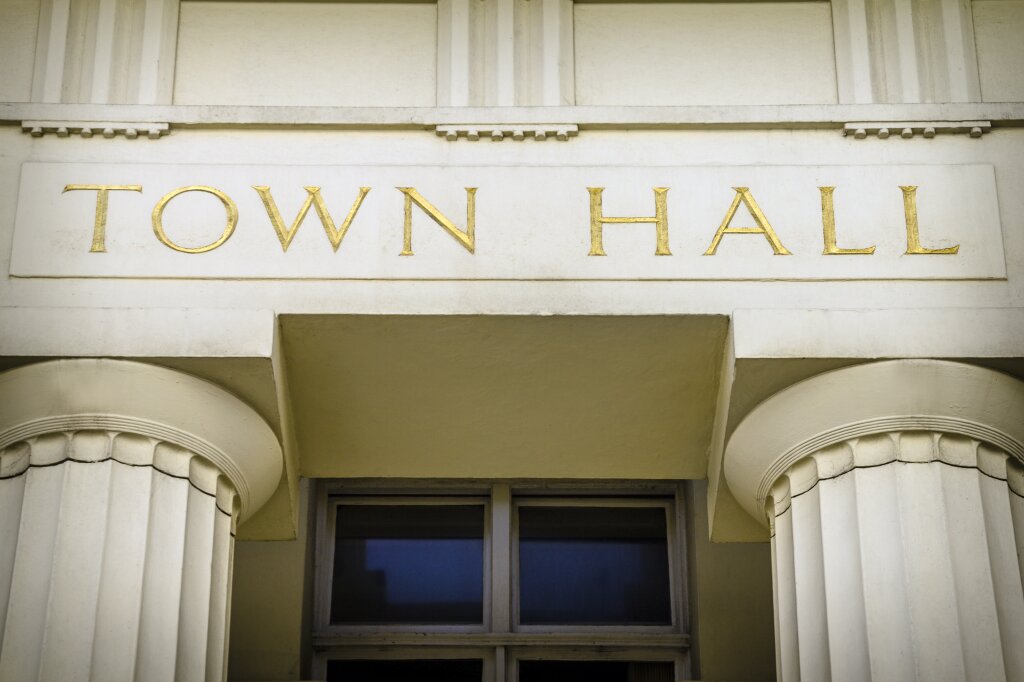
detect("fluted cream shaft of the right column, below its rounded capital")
[765,431,1024,680]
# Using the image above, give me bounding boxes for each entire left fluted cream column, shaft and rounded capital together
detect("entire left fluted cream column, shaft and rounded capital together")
[0,360,281,682]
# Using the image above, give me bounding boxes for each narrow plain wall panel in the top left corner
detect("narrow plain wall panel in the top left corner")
[0,0,39,101]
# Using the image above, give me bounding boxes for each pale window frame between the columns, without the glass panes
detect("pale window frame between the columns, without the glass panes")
[311,479,692,682]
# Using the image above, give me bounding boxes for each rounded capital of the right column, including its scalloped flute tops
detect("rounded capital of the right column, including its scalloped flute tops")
[724,359,1024,525]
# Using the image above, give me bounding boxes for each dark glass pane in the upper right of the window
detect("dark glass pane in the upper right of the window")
[519,506,672,625]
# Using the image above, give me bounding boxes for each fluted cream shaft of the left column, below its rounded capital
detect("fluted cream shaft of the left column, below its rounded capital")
[0,430,238,682]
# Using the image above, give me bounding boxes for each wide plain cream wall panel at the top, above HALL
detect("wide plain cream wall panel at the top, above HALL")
[574,2,837,104]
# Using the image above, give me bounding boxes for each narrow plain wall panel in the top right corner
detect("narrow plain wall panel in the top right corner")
[973,0,1024,101]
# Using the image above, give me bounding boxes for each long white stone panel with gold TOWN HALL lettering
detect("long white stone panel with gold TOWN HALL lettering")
[11,163,1006,280]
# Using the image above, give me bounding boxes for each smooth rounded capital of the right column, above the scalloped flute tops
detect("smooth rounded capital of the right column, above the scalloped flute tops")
[724,359,1024,525]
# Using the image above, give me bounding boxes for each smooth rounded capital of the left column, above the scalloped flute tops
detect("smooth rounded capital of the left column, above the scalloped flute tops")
[0,358,283,520]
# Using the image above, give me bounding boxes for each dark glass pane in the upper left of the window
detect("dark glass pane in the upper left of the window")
[331,505,483,624]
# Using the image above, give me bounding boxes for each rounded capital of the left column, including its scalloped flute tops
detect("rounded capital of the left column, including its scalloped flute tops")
[0,359,283,520]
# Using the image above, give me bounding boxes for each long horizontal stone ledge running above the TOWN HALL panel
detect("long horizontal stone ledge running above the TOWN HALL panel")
[0,102,1024,130]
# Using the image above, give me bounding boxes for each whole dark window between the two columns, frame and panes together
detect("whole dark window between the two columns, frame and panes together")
[313,481,689,682]
